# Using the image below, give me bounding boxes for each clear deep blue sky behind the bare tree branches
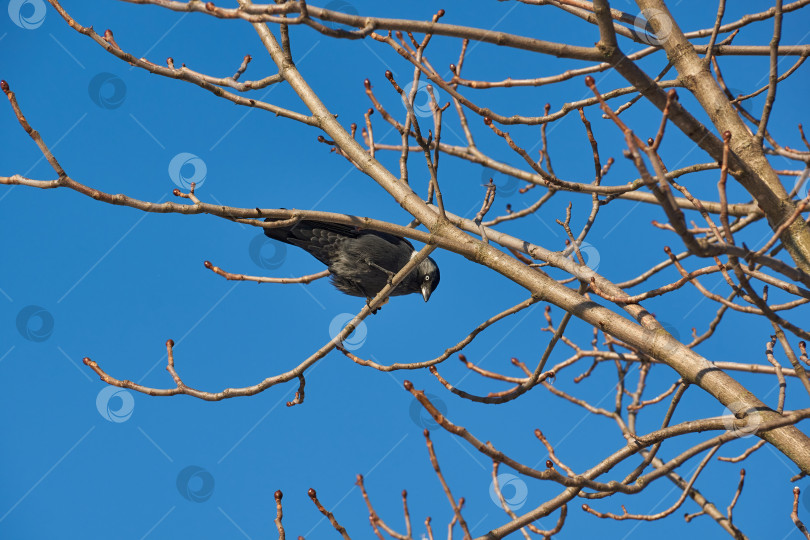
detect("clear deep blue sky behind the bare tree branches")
[0,0,810,539]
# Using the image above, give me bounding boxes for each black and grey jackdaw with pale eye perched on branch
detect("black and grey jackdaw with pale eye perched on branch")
[264,218,439,302]
